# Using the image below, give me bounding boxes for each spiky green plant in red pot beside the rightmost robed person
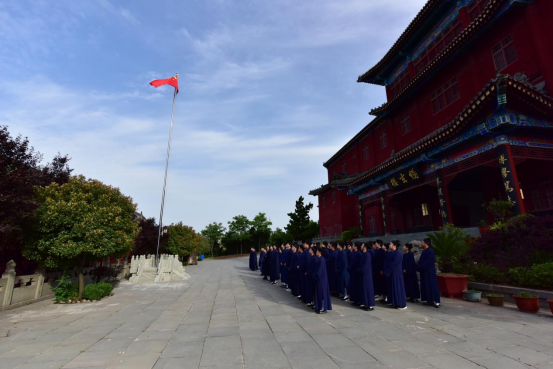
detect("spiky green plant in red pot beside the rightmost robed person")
[428,224,469,298]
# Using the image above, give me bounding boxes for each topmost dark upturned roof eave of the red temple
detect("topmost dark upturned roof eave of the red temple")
[357,0,442,85]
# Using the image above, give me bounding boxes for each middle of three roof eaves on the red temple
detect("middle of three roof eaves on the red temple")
[366,0,504,116]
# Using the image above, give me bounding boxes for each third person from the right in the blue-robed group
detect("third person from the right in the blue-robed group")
[384,241,407,310]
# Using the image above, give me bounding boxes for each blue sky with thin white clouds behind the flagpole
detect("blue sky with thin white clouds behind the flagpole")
[0,0,425,230]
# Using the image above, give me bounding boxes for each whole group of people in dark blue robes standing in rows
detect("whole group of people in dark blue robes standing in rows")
[250,238,440,314]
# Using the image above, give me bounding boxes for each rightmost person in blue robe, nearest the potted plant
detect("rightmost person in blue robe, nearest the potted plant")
[417,238,440,308]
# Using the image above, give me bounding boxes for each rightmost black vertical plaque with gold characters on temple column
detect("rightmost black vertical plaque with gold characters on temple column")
[497,144,526,215]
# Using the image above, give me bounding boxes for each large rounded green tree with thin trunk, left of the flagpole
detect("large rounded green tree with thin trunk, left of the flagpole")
[24,176,138,299]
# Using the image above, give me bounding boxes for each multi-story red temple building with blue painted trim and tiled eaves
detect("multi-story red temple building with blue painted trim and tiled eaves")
[310,0,553,236]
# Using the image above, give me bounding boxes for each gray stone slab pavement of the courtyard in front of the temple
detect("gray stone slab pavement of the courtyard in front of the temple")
[0,258,553,369]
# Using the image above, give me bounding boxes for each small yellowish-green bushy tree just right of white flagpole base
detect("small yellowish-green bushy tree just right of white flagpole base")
[167,222,209,257]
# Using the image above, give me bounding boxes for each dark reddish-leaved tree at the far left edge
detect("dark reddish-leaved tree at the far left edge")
[0,126,72,273]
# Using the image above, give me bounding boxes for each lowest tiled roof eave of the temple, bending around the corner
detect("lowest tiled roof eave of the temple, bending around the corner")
[350,75,553,190]
